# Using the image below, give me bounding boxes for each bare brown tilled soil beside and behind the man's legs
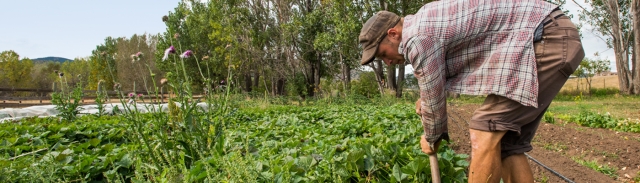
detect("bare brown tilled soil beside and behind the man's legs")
[449,104,640,182]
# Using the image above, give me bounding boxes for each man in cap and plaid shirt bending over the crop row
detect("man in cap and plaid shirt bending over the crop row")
[359,0,584,182]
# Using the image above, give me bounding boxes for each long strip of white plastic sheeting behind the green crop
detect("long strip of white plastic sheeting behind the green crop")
[0,102,208,123]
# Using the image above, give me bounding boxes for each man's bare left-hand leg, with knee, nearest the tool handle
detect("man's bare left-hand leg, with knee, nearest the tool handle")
[469,129,507,183]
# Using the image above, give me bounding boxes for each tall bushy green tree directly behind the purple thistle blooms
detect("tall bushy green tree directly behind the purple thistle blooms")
[155,0,244,93]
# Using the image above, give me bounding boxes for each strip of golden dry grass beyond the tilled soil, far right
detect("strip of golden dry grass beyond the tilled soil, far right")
[560,75,620,92]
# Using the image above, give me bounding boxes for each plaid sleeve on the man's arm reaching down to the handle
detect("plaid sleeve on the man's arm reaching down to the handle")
[404,35,448,148]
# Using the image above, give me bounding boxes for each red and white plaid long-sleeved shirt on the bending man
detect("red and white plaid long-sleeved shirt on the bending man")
[398,0,557,146]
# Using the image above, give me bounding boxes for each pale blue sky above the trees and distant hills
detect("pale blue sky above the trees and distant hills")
[0,0,615,70]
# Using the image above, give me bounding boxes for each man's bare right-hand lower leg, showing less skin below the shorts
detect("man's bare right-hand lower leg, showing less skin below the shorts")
[502,153,533,183]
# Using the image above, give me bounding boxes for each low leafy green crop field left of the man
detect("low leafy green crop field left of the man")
[0,103,468,182]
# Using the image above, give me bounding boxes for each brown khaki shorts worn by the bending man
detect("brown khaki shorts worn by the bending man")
[469,16,584,158]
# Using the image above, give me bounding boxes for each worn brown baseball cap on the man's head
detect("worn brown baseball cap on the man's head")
[358,11,400,65]
